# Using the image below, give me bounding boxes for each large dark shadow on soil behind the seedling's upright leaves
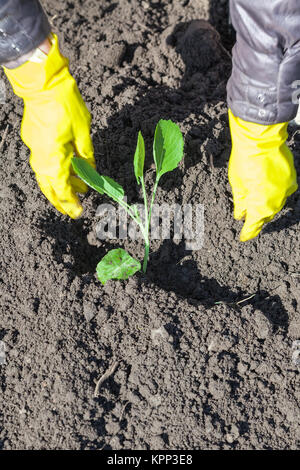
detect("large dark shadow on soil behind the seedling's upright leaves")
[94,20,231,187]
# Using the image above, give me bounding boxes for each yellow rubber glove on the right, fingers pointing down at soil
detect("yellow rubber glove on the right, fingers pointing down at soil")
[228,110,298,242]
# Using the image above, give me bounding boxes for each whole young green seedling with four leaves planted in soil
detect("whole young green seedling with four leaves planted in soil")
[72,119,183,284]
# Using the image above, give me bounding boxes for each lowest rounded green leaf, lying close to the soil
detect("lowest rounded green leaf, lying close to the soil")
[97,248,141,285]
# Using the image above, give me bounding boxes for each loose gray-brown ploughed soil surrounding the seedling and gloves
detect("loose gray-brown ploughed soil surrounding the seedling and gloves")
[0,0,300,450]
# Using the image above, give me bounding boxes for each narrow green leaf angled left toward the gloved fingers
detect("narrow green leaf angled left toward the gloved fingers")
[72,157,124,202]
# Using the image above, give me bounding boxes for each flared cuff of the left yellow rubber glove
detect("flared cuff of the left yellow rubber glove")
[3,34,69,99]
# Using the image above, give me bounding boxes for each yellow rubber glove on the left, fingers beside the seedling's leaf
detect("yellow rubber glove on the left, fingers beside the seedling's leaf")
[4,35,95,218]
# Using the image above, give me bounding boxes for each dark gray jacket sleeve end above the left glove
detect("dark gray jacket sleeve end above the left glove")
[0,0,50,64]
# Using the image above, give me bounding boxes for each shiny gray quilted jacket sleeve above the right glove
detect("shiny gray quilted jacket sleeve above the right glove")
[227,0,300,124]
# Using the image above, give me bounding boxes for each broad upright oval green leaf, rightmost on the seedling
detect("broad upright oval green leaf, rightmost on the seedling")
[153,119,183,178]
